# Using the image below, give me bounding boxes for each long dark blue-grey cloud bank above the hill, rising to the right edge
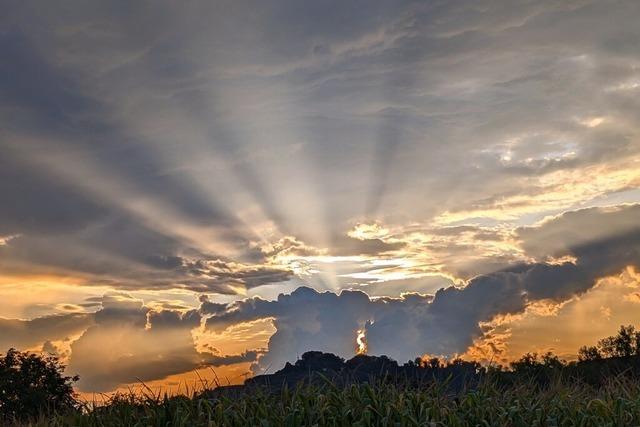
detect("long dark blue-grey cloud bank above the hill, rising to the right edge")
[202,217,640,372]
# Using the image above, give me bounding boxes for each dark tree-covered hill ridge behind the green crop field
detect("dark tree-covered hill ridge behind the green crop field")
[212,326,640,392]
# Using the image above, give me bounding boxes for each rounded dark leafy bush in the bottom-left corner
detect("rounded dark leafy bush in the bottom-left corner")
[0,348,78,424]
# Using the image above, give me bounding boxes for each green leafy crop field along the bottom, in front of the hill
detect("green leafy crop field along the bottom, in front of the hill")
[19,376,640,427]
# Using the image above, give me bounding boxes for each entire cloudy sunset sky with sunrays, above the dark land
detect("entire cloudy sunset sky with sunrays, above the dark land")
[0,0,640,393]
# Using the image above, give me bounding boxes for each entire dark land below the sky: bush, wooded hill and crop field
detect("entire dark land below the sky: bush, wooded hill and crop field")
[0,327,640,426]
